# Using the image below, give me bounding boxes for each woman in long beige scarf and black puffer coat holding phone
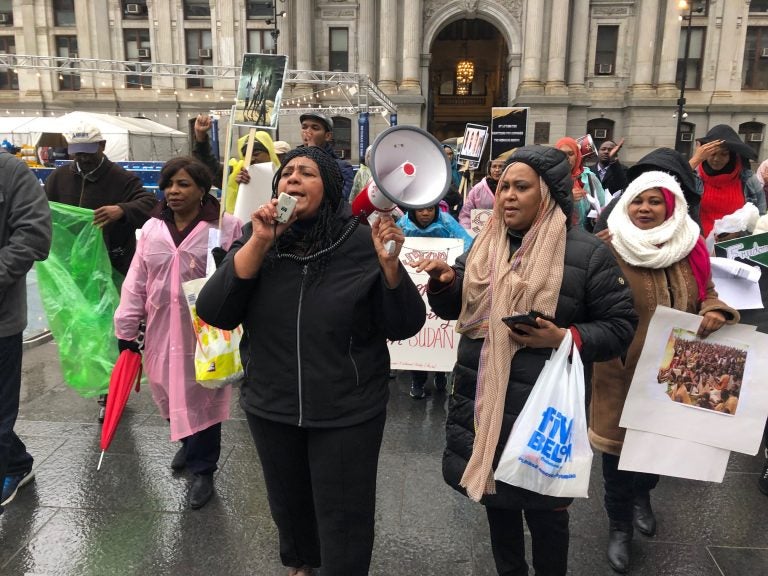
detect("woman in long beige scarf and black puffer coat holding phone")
[414,146,637,576]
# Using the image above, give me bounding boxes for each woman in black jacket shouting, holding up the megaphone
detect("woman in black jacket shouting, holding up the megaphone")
[197,147,426,576]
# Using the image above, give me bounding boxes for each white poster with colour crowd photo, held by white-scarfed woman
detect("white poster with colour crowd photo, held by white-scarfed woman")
[619,306,768,455]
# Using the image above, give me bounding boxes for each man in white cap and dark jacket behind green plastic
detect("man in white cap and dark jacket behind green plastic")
[45,123,157,422]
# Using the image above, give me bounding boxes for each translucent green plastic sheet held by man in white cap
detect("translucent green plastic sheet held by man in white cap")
[35,202,120,397]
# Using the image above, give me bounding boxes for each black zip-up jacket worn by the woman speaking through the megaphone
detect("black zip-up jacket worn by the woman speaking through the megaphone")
[197,212,426,428]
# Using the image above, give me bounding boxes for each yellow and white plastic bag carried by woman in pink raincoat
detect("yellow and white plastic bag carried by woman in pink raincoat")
[181,278,243,388]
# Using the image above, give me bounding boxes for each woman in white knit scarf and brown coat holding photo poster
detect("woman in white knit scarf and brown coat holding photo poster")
[589,171,739,573]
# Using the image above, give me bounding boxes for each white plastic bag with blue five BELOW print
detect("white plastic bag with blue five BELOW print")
[494,331,592,498]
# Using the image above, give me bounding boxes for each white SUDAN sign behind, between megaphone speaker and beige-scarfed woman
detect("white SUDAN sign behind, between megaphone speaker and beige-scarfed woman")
[389,237,464,372]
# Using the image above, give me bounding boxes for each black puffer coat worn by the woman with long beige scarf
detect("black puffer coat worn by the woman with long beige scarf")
[428,227,637,509]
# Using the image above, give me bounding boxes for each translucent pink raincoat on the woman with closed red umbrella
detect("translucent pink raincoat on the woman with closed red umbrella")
[115,213,241,441]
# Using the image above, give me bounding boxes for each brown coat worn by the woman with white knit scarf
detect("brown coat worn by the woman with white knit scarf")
[589,253,739,456]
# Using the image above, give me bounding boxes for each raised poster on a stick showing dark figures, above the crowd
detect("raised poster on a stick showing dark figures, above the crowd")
[234,54,288,130]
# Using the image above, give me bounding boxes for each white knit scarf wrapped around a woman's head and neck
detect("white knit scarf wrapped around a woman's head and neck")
[608,171,700,269]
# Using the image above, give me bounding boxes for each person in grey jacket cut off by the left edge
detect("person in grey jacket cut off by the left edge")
[0,150,51,514]
